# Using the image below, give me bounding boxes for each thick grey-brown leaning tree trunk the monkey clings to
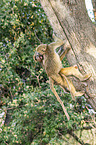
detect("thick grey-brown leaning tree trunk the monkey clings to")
[40,0,96,110]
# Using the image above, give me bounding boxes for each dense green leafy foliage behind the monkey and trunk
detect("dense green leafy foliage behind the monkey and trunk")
[0,0,95,145]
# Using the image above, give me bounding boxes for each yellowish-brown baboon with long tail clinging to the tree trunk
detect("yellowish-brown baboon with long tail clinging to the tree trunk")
[34,36,90,120]
